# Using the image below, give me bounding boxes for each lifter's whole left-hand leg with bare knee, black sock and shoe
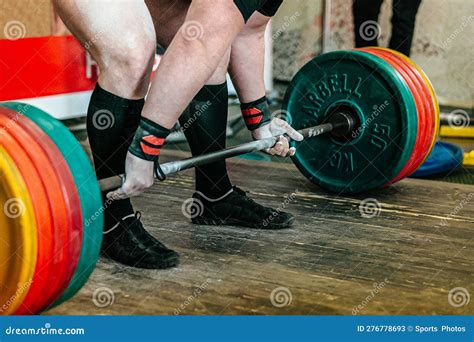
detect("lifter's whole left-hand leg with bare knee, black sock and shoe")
[54,0,179,269]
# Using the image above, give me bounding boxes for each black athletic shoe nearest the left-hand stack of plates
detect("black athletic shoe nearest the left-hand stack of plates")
[102,212,179,269]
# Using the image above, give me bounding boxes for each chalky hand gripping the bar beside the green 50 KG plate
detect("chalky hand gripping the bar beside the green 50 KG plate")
[252,118,303,157]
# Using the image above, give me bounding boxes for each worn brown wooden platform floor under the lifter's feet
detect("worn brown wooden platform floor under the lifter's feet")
[48,152,474,315]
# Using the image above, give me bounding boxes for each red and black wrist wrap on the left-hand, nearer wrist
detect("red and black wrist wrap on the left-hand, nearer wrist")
[129,118,170,162]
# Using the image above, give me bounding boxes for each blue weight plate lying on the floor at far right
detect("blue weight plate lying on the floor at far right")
[410,141,463,178]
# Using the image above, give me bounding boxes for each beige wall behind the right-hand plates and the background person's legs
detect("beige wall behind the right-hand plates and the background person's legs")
[273,0,474,108]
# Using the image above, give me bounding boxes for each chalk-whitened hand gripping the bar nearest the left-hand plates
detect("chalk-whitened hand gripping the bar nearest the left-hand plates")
[107,152,155,200]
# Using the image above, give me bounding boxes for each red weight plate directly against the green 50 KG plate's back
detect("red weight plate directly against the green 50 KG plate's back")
[360,48,427,184]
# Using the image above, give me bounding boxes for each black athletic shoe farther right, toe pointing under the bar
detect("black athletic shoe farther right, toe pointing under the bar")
[192,186,295,229]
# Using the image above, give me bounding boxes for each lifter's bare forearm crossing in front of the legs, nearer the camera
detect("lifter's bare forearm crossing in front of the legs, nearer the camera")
[139,0,244,128]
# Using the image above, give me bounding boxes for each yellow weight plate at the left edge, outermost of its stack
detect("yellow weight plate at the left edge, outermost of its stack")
[0,146,38,315]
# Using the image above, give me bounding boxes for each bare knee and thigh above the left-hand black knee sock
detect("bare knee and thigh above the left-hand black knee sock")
[53,0,156,99]
